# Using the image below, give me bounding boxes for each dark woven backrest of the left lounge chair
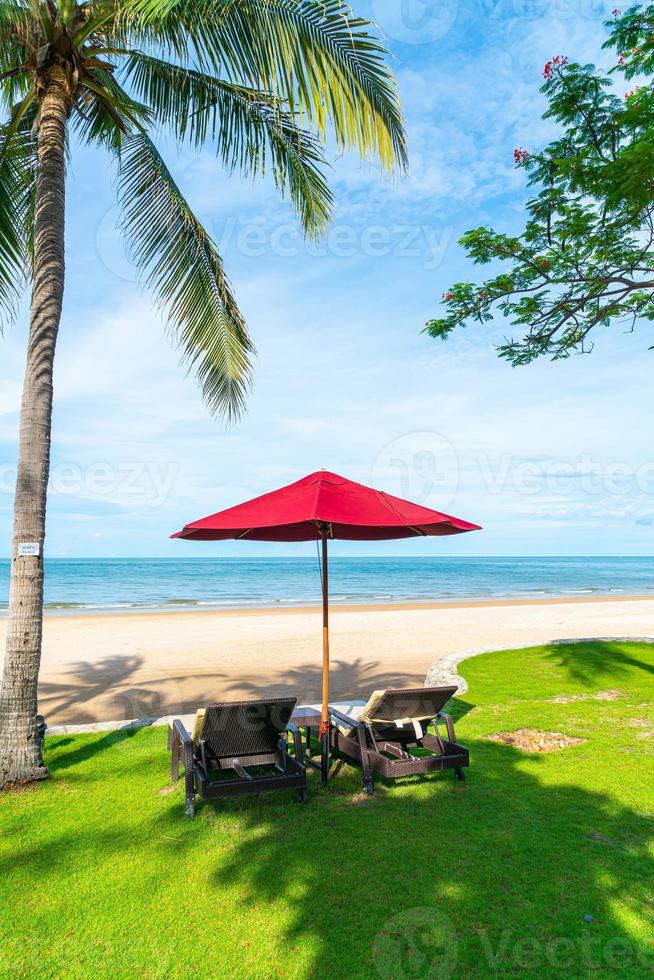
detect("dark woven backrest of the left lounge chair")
[200,698,297,759]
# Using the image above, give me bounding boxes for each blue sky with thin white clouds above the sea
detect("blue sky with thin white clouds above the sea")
[0,0,654,557]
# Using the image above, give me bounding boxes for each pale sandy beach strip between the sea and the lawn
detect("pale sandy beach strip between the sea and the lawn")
[0,596,654,724]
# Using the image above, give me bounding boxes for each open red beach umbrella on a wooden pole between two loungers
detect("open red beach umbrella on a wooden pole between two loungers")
[173,470,480,775]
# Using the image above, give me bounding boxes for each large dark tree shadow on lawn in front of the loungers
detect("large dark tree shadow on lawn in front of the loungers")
[201,744,654,980]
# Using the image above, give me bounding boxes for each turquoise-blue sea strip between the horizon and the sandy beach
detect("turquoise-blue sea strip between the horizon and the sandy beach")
[0,557,654,615]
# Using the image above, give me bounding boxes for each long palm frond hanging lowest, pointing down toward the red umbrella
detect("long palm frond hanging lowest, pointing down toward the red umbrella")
[118,132,254,420]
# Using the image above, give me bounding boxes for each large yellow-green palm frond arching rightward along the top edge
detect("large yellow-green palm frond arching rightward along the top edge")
[131,0,407,169]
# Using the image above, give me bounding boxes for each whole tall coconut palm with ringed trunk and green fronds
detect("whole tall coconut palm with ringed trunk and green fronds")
[0,0,406,787]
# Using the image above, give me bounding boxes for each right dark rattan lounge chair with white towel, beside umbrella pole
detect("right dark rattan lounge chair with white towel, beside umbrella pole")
[330,686,470,794]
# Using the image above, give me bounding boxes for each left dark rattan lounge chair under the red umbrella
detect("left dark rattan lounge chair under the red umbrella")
[168,698,307,817]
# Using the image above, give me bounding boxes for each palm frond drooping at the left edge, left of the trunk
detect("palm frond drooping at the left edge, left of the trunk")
[0,115,36,326]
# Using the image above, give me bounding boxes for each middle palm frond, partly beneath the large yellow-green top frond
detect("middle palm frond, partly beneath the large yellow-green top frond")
[126,52,333,236]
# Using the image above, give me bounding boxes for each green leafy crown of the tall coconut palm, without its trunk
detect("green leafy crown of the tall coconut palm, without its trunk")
[0,0,406,417]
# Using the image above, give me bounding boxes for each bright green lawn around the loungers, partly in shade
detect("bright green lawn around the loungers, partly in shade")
[0,642,654,980]
